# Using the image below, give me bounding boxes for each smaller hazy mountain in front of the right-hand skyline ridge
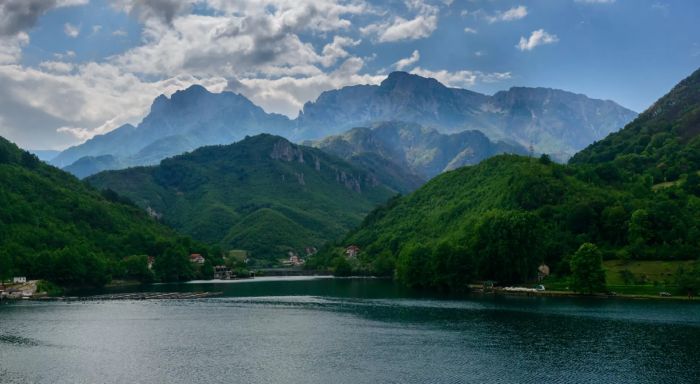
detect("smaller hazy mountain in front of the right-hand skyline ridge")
[312,122,528,180]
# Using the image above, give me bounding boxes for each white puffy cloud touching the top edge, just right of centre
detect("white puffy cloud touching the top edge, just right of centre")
[360,0,438,43]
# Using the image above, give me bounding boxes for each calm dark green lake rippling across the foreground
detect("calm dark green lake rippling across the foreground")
[0,278,700,384]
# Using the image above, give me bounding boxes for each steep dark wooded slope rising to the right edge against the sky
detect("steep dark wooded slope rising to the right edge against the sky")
[571,69,700,183]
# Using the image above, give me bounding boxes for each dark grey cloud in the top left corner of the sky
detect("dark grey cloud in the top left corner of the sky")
[0,0,89,36]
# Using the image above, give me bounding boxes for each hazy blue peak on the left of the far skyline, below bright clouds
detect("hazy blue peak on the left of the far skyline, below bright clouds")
[52,85,292,167]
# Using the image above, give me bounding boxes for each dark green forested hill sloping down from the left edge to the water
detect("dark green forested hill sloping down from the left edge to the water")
[0,137,206,286]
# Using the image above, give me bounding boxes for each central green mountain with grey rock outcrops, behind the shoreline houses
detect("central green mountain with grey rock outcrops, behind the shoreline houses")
[87,135,396,258]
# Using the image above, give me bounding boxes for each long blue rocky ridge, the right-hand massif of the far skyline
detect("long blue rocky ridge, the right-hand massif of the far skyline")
[297,72,636,160]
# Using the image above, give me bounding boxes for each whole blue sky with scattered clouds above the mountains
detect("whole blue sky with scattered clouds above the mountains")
[0,0,700,149]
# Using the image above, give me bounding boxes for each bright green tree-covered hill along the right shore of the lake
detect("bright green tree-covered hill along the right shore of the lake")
[309,155,700,290]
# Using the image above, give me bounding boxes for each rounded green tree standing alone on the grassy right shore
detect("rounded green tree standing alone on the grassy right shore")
[570,243,605,294]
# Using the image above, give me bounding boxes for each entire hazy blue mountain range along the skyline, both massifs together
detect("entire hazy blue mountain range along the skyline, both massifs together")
[52,72,636,177]
